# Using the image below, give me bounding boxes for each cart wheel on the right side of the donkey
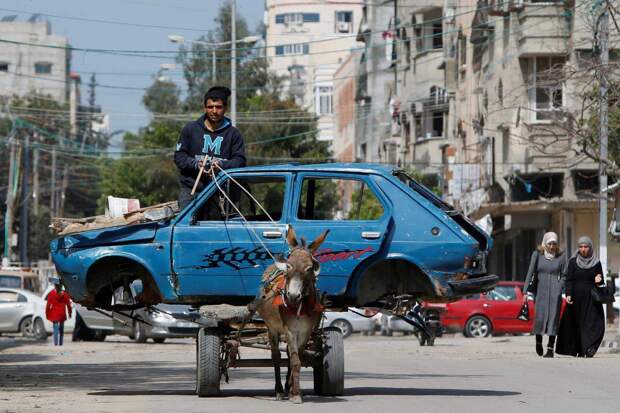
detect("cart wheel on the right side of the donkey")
[313,327,344,396]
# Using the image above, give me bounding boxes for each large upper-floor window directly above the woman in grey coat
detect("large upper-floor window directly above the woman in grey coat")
[529,56,565,120]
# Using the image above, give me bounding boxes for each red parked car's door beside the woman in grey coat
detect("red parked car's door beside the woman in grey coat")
[482,285,521,331]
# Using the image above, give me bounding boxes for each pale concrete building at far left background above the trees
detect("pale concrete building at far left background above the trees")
[0,15,71,102]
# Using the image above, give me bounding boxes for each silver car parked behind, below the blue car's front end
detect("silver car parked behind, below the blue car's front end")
[73,304,198,343]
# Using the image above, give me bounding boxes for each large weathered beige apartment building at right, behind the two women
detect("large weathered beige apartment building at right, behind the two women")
[442,0,620,279]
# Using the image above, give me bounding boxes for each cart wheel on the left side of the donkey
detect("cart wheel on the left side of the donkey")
[196,328,222,397]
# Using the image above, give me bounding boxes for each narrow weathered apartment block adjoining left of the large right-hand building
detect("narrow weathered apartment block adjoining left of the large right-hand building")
[396,0,449,177]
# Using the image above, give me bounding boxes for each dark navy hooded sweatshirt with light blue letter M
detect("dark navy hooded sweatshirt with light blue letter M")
[174,115,246,191]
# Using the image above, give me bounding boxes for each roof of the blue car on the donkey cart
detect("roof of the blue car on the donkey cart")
[227,162,399,175]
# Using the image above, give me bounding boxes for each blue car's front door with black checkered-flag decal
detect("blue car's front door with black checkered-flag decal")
[172,172,292,296]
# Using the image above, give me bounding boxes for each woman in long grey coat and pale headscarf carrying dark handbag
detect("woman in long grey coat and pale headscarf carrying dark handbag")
[523,232,567,357]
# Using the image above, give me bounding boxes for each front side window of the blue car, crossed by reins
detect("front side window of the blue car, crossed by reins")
[195,176,286,222]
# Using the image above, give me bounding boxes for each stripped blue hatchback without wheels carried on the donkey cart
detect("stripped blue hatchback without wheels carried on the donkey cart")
[50,163,498,309]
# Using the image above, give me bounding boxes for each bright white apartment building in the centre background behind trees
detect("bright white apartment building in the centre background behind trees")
[266,0,363,141]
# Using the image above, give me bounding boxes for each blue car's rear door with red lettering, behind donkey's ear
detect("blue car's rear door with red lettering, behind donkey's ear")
[291,172,391,295]
